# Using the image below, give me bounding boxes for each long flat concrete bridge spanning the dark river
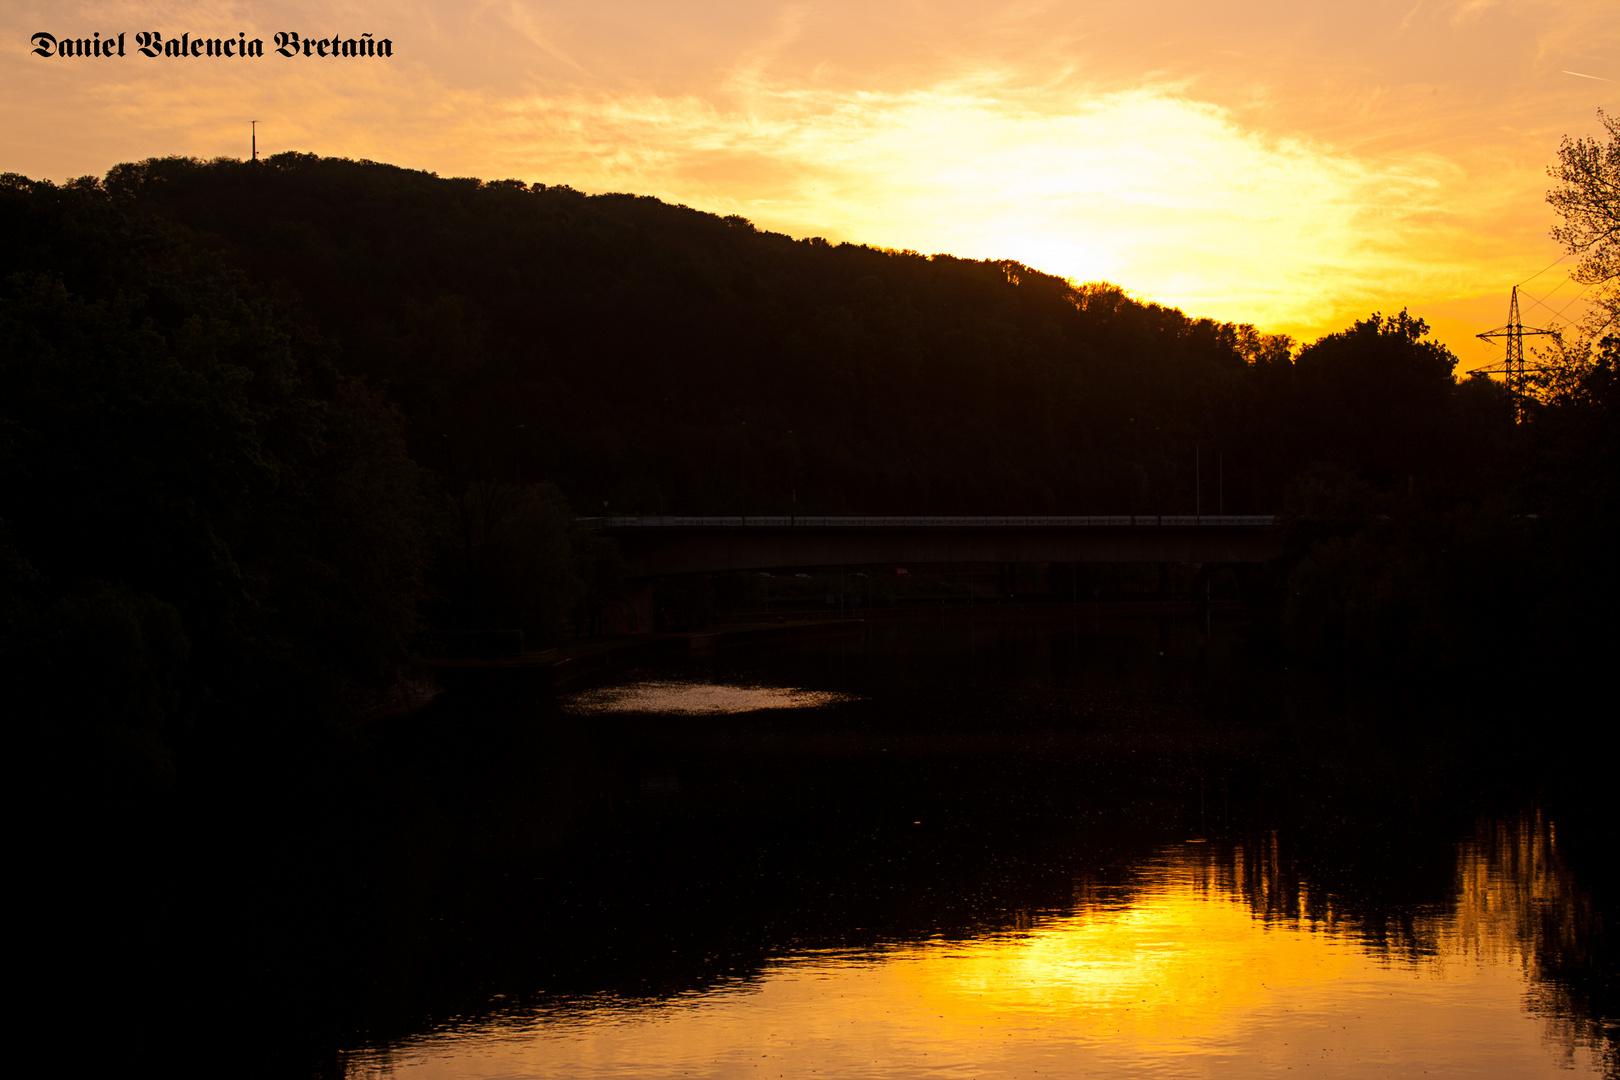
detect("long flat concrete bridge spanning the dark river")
[585,513,1281,595]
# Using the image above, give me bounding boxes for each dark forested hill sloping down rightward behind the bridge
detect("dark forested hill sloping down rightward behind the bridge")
[105,154,1505,513]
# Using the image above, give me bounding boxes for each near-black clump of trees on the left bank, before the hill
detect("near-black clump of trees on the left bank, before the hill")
[0,176,434,767]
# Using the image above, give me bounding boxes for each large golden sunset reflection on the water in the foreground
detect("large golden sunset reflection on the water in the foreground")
[350,823,1602,1080]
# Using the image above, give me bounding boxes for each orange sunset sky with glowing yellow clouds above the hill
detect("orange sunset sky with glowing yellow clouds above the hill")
[0,0,1620,369]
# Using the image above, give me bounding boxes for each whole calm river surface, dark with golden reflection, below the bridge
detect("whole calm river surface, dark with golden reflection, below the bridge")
[161,619,1617,1080]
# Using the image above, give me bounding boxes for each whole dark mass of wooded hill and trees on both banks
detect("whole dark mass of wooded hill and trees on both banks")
[0,154,1620,756]
